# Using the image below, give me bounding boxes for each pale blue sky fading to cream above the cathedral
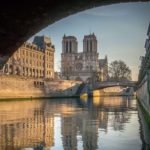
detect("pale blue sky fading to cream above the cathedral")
[28,2,150,80]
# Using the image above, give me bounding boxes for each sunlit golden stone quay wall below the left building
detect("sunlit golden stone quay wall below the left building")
[0,75,81,99]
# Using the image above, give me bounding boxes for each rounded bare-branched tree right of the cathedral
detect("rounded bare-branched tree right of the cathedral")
[109,60,131,81]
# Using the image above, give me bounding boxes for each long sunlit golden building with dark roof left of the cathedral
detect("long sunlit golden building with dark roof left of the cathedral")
[3,36,55,79]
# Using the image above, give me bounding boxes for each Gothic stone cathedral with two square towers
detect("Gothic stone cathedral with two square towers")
[61,33,108,81]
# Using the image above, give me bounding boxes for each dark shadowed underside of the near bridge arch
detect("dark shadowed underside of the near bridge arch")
[0,0,148,68]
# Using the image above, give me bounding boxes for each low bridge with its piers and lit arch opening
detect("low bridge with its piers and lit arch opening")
[80,81,136,98]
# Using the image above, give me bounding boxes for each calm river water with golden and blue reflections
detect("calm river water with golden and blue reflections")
[0,97,150,150]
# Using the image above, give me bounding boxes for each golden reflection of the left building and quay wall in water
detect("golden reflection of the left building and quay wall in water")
[0,101,54,150]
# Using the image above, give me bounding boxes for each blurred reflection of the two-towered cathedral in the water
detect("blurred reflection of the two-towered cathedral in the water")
[61,111,102,150]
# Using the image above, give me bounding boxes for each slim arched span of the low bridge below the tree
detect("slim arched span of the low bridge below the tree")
[92,81,136,90]
